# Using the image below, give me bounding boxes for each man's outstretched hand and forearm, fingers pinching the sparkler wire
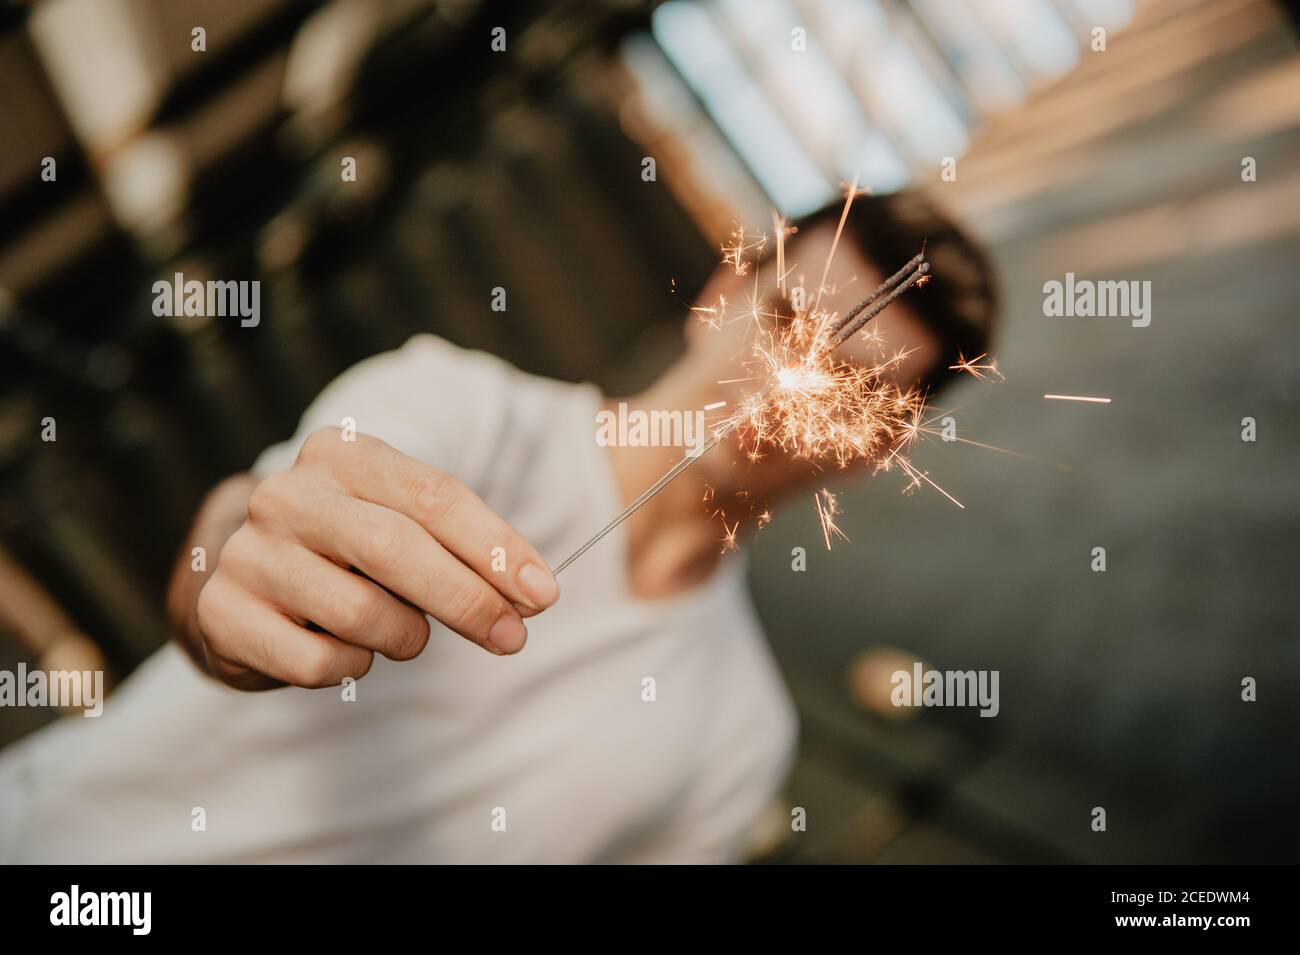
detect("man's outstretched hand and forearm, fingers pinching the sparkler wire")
[168,427,559,690]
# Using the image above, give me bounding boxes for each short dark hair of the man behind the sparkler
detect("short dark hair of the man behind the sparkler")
[796,190,998,388]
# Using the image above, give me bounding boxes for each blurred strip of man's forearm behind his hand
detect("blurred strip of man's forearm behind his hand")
[166,474,257,670]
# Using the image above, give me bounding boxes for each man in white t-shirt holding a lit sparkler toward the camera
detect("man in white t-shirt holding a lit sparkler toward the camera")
[0,194,993,861]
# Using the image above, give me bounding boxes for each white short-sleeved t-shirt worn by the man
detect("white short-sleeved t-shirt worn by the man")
[0,335,796,863]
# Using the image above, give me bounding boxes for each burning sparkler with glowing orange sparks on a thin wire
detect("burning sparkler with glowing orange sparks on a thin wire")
[543,219,932,574]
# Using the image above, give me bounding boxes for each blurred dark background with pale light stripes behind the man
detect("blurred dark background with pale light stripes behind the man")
[0,0,1300,863]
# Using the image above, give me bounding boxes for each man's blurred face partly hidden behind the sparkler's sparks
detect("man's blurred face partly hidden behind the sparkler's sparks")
[686,223,940,387]
